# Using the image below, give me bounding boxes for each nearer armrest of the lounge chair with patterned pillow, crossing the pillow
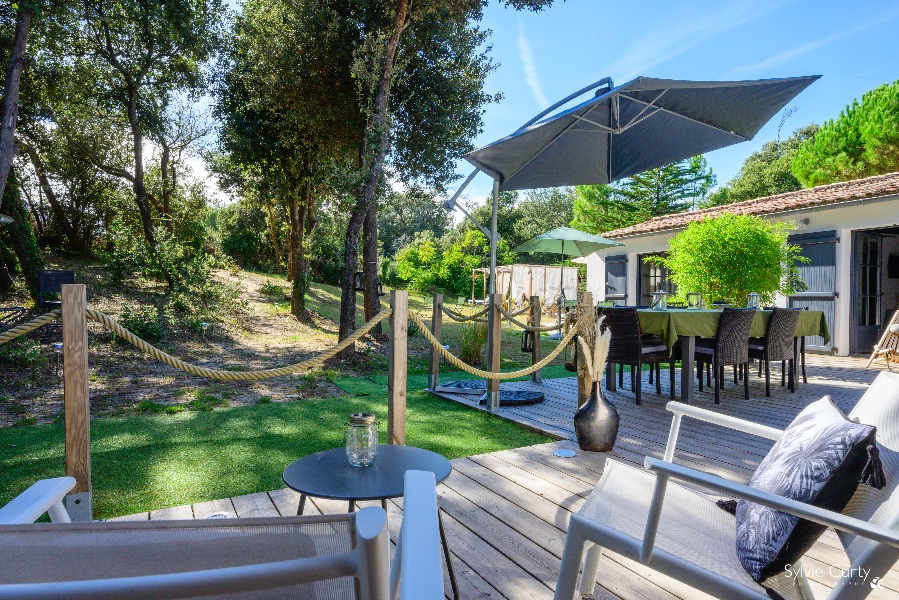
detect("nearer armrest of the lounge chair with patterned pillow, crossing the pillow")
[644,457,899,548]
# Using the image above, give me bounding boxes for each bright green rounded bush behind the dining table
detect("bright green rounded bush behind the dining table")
[646,212,808,305]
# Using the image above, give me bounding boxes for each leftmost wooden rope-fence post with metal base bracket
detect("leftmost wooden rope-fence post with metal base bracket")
[61,284,93,521]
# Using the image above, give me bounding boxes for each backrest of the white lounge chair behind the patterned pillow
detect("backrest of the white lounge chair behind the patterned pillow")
[831,372,899,598]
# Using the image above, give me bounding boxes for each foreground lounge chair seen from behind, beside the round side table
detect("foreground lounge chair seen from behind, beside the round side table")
[0,471,443,600]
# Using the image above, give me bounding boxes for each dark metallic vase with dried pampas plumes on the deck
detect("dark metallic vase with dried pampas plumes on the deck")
[574,317,620,452]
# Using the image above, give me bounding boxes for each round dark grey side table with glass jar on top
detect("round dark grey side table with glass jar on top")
[282,444,459,599]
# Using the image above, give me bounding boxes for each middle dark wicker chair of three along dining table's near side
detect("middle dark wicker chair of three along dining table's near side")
[696,308,755,404]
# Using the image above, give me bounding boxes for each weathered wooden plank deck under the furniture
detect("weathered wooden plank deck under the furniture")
[112,356,899,600]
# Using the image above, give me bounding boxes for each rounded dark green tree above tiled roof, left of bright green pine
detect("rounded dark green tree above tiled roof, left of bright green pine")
[701,124,818,208]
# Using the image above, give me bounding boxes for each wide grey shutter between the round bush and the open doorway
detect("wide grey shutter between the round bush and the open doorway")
[789,231,839,351]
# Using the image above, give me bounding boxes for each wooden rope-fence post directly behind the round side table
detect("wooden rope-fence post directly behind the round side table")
[387,290,409,446]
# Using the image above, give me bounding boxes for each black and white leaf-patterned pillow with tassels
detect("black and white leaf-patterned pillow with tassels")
[736,396,876,581]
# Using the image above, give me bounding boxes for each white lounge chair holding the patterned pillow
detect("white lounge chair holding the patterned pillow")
[555,372,899,600]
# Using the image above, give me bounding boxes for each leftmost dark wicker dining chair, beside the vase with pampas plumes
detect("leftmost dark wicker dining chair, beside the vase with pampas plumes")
[596,307,668,404]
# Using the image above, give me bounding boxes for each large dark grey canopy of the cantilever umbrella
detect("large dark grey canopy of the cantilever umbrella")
[465,75,820,191]
